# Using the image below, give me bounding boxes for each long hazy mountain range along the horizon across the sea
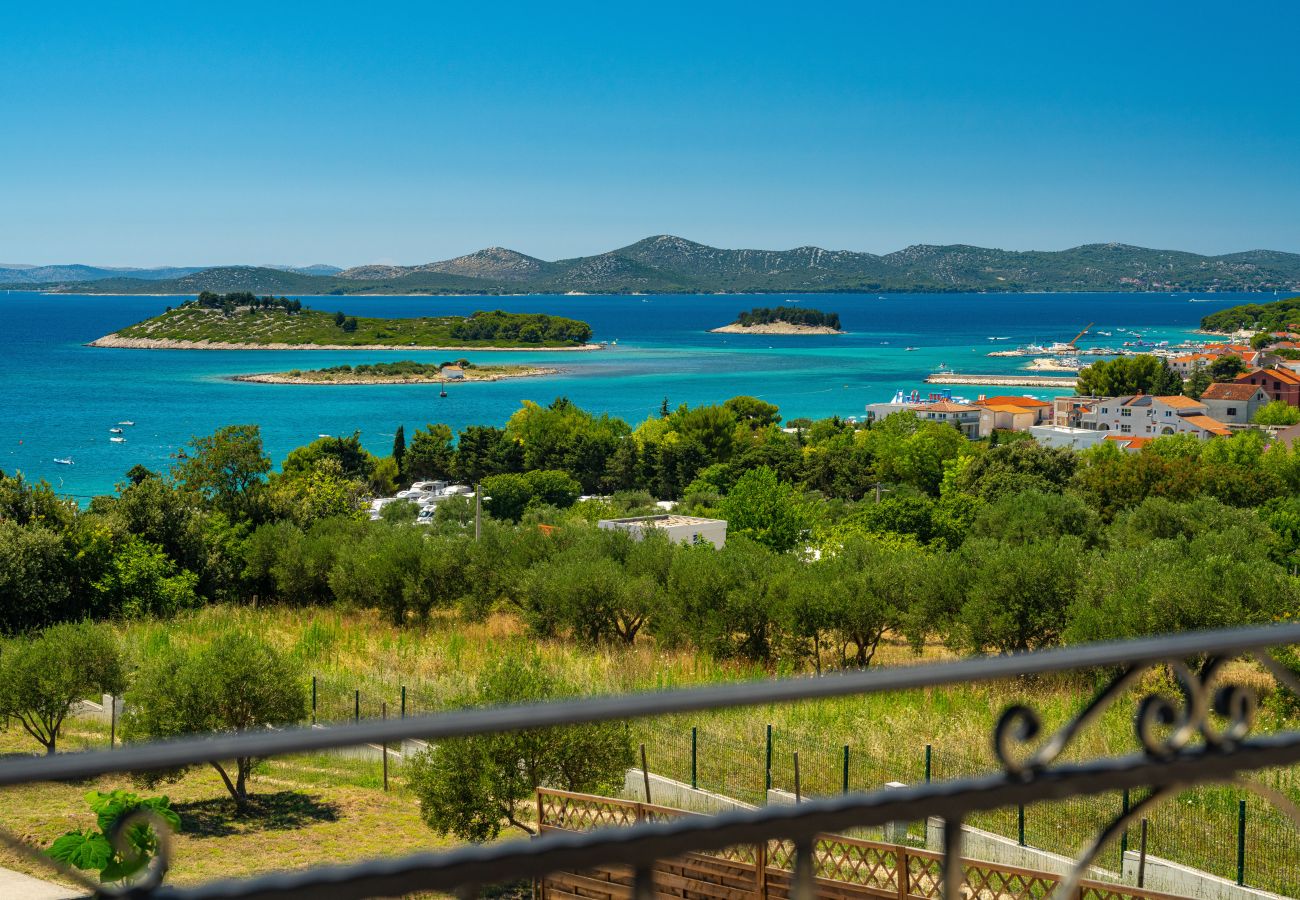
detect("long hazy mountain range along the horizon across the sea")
[0,234,1300,294]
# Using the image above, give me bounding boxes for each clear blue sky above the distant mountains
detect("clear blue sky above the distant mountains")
[0,0,1300,265]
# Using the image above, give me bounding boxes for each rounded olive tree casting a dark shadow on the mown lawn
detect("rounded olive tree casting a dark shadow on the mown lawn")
[124,631,307,808]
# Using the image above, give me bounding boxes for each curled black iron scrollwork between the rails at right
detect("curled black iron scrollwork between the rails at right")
[993,650,1300,897]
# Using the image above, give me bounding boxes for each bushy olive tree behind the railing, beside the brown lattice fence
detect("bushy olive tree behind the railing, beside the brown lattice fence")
[407,655,632,841]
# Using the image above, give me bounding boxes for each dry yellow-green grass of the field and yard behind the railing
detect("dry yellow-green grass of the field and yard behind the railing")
[0,607,1300,893]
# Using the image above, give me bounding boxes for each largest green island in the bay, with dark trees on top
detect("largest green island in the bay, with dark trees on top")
[90,291,598,350]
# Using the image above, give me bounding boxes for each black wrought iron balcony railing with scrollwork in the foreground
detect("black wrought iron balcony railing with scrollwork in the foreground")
[0,624,1300,900]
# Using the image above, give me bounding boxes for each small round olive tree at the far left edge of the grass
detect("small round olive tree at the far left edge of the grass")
[0,623,125,753]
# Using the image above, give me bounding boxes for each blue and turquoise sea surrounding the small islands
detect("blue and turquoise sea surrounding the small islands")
[0,293,1273,502]
